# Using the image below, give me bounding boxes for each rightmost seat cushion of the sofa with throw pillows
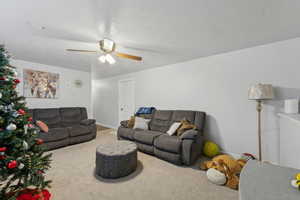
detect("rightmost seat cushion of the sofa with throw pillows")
[154,134,182,153]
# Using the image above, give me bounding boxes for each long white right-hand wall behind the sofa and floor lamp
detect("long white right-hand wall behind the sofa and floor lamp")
[92,38,300,162]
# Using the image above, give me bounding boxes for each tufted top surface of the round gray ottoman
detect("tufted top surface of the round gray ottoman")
[97,141,137,156]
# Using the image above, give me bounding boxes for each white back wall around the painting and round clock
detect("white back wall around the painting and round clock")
[10,60,91,116]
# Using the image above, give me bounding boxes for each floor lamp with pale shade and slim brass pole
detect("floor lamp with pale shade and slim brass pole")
[248,83,274,161]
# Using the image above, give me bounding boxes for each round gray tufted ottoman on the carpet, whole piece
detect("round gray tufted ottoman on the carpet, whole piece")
[96,141,137,178]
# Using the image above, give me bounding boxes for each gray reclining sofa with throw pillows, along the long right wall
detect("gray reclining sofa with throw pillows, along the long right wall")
[117,110,206,165]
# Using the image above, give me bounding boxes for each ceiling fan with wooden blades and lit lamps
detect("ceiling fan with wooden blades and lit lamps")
[66,38,142,64]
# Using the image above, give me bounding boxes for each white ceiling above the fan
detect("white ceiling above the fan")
[0,0,300,77]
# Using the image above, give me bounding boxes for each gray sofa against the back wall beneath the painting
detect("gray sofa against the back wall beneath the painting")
[29,107,97,150]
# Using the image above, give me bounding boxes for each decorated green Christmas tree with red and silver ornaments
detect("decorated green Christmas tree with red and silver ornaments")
[0,45,51,200]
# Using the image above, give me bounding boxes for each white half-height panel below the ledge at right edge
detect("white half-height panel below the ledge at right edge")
[278,113,300,169]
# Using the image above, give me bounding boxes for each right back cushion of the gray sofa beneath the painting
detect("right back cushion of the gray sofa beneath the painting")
[59,108,82,127]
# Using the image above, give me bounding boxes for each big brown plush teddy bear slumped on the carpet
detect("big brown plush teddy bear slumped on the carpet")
[200,155,246,189]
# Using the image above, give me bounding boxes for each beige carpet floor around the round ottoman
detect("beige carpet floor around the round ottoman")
[48,130,238,200]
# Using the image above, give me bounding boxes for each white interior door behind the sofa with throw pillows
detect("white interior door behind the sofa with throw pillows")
[119,80,135,121]
